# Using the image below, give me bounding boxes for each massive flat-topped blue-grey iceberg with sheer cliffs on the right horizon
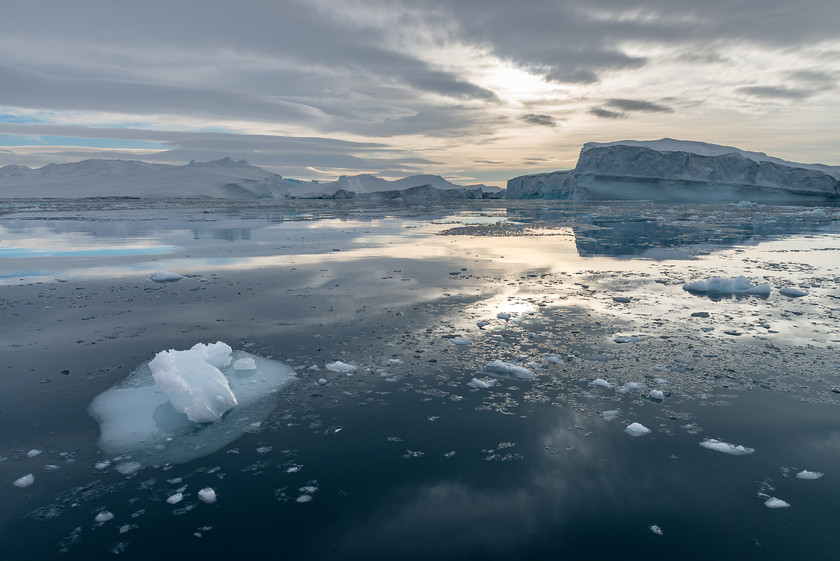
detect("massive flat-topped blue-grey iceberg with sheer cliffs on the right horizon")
[506,138,840,202]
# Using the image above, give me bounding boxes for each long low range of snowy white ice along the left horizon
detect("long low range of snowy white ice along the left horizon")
[0,158,501,200]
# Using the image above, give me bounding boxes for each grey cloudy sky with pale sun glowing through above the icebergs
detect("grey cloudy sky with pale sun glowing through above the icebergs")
[0,0,840,186]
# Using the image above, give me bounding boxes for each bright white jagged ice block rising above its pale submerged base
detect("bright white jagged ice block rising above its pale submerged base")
[149,341,238,423]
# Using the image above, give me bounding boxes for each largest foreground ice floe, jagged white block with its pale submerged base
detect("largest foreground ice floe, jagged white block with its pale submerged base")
[88,341,295,465]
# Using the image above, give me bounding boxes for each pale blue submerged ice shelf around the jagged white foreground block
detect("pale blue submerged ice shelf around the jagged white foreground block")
[88,345,294,464]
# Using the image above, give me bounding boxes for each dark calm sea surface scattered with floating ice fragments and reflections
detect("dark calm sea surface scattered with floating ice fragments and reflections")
[0,199,840,560]
